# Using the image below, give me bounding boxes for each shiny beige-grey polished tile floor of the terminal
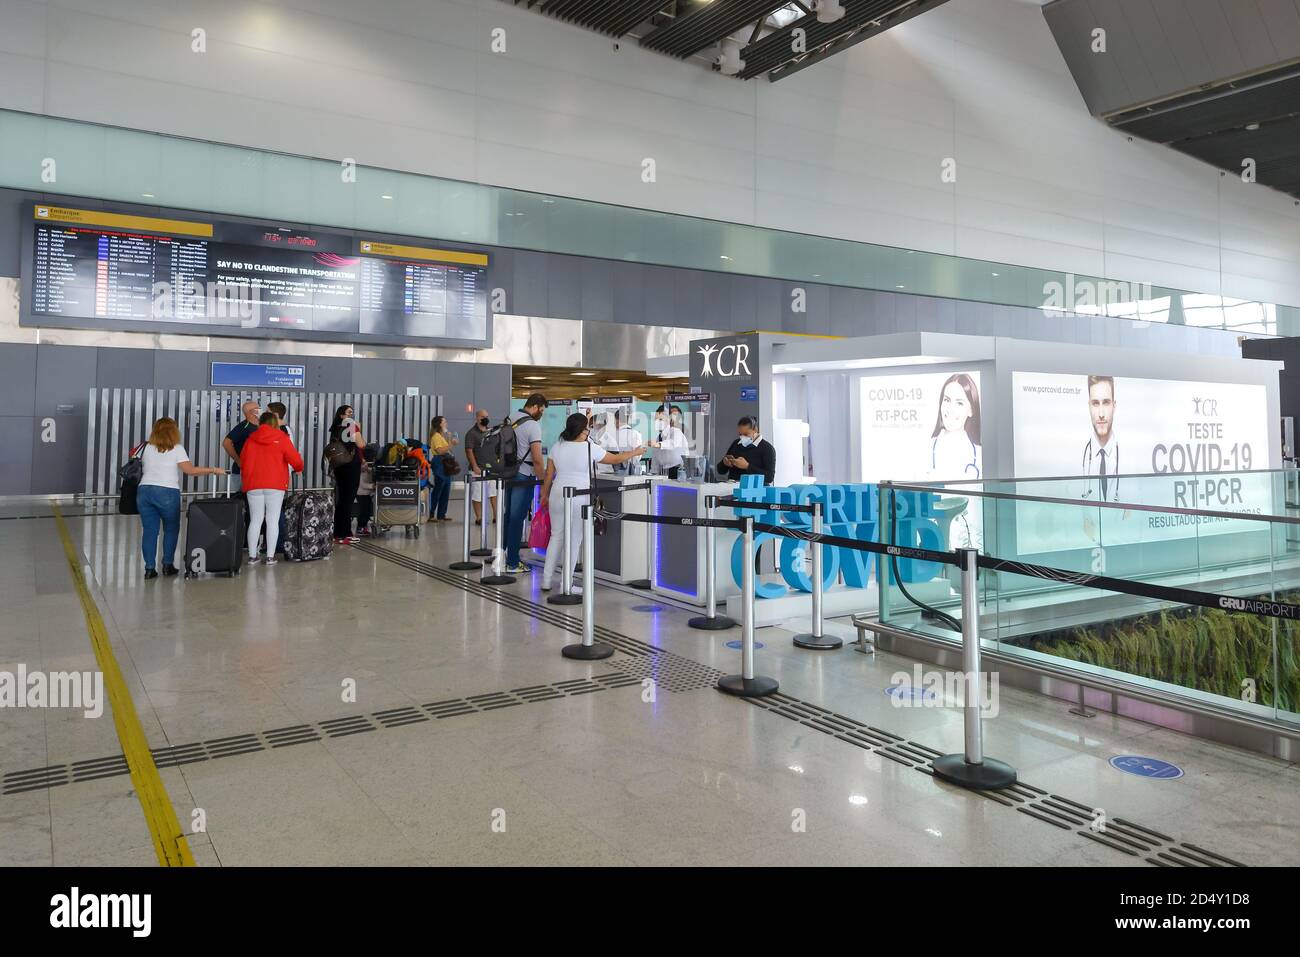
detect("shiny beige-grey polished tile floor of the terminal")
[0,505,1300,866]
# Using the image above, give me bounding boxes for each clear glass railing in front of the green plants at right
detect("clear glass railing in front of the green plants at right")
[878,469,1300,726]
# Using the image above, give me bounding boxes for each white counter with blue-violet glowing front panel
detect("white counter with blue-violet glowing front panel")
[649,480,738,607]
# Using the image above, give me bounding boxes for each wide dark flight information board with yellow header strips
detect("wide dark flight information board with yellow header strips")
[21,205,489,345]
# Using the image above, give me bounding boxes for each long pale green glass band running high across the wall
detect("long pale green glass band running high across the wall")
[0,111,1300,335]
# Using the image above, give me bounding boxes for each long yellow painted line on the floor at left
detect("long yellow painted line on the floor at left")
[55,505,195,867]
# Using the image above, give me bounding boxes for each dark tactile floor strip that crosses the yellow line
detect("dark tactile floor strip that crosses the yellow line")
[0,674,641,794]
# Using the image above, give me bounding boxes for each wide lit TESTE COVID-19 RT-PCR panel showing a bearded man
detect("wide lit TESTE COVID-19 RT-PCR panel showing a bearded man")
[1011,372,1273,553]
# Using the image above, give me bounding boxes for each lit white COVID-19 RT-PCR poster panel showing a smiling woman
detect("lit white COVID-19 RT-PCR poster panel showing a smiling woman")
[858,371,989,549]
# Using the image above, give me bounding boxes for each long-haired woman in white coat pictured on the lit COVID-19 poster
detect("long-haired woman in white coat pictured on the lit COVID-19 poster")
[930,372,984,549]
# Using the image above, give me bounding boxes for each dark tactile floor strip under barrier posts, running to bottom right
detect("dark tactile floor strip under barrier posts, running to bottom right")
[745,692,1247,867]
